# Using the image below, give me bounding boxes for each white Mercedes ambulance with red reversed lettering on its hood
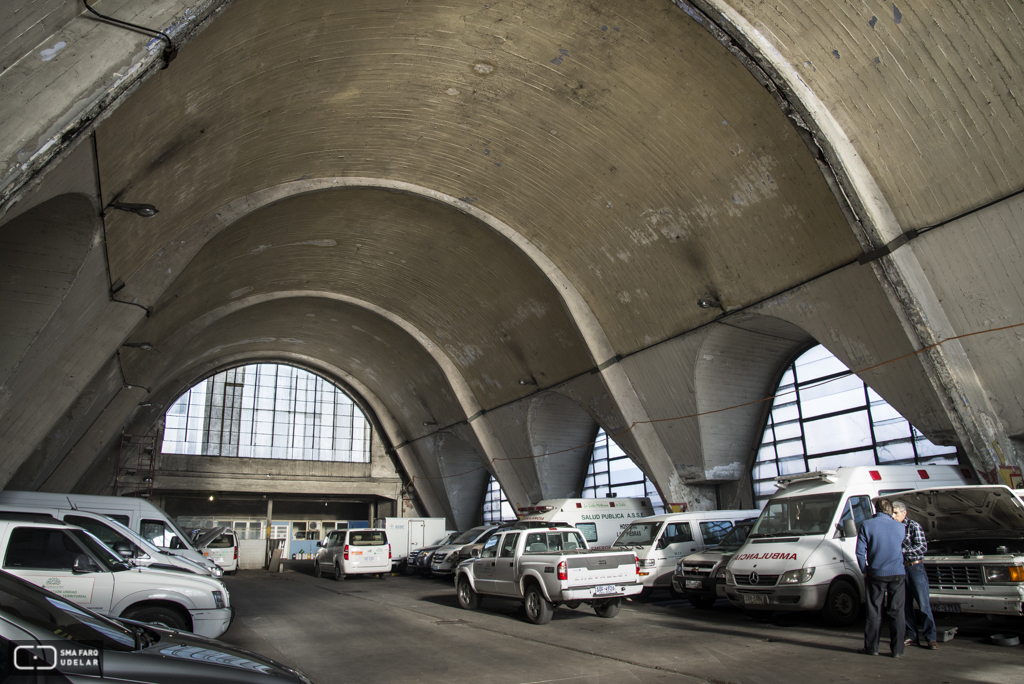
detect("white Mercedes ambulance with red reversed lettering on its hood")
[725,466,977,626]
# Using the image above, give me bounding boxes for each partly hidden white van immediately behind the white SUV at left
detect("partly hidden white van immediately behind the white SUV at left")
[0,505,213,576]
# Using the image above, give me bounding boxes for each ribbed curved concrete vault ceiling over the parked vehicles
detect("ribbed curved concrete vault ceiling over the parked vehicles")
[0,0,1024,526]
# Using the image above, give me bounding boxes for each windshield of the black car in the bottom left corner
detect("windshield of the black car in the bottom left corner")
[0,571,135,651]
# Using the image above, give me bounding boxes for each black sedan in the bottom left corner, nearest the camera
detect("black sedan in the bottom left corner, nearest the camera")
[0,570,312,684]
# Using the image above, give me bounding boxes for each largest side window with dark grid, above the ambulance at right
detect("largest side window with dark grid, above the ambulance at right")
[752,345,957,506]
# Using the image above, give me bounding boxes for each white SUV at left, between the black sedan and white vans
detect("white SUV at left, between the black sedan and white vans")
[0,512,233,638]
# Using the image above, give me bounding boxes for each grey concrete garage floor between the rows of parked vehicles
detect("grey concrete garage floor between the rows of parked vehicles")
[221,562,1024,684]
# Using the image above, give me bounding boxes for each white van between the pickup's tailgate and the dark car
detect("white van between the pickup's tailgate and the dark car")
[612,508,761,598]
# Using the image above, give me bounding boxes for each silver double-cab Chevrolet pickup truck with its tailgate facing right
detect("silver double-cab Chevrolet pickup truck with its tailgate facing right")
[455,527,643,625]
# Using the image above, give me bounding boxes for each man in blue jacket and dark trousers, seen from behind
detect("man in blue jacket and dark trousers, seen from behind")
[857,499,906,657]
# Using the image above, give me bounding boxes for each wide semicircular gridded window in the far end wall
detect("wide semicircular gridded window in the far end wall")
[162,364,370,463]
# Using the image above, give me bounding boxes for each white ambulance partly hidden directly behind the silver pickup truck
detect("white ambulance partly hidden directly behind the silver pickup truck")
[519,497,654,549]
